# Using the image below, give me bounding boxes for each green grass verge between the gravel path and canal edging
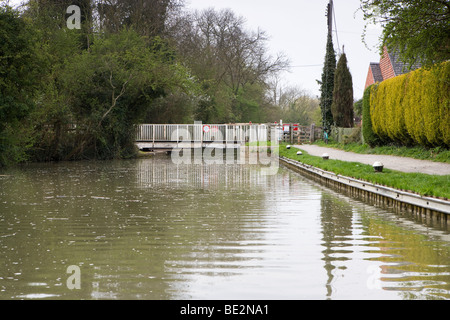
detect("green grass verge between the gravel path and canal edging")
[279,144,450,199]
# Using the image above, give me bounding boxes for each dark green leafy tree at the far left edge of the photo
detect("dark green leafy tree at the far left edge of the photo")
[0,5,41,166]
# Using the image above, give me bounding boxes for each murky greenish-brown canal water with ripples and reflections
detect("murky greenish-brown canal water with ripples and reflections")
[0,156,450,300]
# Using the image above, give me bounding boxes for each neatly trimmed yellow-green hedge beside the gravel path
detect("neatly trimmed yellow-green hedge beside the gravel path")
[370,61,450,147]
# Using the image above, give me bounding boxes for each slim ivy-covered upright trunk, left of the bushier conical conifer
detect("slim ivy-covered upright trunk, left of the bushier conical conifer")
[318,34,336,132]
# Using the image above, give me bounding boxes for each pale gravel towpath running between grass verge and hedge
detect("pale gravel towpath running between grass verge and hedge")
[294,145,450,175]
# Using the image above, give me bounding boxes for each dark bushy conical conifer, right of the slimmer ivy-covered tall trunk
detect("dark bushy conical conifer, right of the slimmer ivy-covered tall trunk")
[331,53,354,128]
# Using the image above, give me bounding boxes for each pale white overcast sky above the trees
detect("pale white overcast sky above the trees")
[186,0,381,99]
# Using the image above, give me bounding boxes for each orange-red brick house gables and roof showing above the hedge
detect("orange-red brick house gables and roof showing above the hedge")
[364,47,420,89]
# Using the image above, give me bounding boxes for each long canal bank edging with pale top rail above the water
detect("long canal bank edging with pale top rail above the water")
[280,157,450,225]
